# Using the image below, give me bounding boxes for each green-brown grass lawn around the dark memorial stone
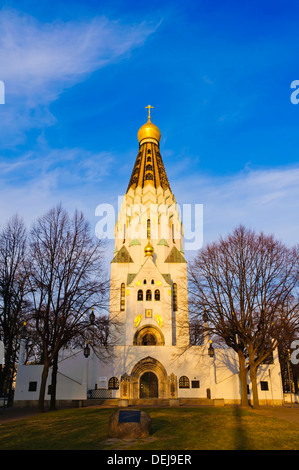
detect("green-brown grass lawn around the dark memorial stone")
[0,407,299,450]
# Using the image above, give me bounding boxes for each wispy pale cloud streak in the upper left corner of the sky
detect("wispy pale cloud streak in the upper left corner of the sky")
[0,8,159,143]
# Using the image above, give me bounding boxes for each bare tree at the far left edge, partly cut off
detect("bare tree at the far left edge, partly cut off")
[0,215,27,402]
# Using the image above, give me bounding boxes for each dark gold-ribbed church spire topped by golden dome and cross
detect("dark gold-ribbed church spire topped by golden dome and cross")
[127,105,170,192]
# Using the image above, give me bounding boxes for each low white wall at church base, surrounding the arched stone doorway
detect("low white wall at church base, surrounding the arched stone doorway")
[15,346,283,404]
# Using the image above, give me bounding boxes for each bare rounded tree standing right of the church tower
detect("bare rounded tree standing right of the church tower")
[190,226,298,406]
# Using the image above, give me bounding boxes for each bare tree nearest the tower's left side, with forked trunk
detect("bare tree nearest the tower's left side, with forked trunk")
[30,205,108,411]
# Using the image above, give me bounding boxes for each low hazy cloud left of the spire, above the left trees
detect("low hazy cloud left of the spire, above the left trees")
[0,148,117,226]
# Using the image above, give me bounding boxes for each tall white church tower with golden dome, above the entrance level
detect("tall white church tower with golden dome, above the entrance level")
[110,106,189,346]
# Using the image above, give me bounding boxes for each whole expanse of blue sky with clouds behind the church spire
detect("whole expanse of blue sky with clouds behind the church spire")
[0,0,299,260]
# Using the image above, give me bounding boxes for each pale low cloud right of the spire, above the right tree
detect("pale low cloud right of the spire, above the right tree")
[172,166,299,248]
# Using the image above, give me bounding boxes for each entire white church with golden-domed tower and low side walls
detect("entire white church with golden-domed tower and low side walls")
[14,107,283,406]
